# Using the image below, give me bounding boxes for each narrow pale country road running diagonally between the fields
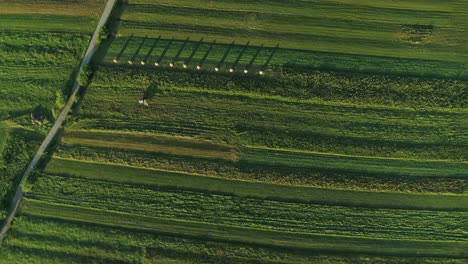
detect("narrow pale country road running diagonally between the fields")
[0,0,117,241]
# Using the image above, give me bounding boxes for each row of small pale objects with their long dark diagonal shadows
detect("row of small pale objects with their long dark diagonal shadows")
[113,34,279,75]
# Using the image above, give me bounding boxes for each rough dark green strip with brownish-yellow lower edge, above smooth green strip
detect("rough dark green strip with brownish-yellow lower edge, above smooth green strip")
[54,144,468,194]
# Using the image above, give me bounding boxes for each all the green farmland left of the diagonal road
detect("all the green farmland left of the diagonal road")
[0,0,103,249]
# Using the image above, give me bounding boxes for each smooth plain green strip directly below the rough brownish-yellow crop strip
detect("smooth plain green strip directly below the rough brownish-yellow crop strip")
[45,158,468,211]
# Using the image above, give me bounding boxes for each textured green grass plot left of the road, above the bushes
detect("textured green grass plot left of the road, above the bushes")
[0,31,89,116]
